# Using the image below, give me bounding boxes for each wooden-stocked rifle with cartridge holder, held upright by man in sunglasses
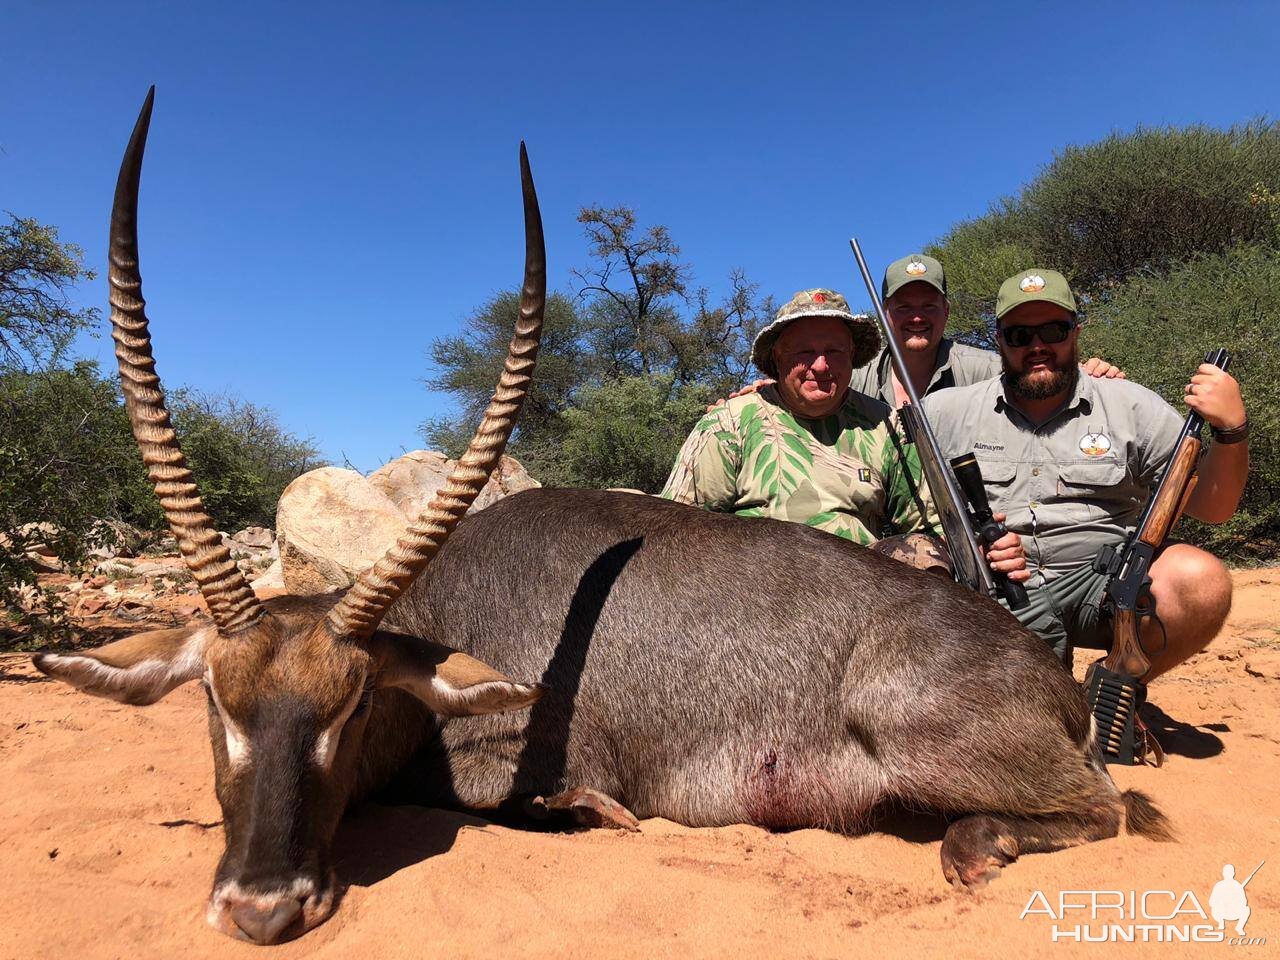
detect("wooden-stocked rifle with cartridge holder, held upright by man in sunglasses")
[1084,349,1231,767]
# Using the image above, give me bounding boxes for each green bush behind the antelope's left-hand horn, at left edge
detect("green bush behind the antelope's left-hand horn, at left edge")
[0,361,324,643]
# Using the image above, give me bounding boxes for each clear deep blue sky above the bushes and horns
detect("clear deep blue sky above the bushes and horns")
[0,0,1280,470]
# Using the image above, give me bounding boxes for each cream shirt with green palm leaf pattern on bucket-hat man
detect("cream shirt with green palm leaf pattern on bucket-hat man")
[659,387,938,545]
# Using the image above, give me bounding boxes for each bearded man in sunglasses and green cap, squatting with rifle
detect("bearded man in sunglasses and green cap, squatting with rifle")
[922,269,1249,682]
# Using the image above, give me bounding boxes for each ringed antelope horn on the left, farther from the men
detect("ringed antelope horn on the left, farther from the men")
[109,87,265,634]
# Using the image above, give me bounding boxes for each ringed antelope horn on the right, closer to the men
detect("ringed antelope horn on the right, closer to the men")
[329,143,547,640]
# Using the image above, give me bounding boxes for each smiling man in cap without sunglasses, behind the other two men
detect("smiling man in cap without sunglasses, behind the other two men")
[852,253,1124,410]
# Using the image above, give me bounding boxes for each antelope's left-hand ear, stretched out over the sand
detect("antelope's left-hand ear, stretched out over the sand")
[33,625,218,707]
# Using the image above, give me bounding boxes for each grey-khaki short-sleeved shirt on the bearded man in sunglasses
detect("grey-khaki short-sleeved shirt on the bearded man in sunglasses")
[920,371,1183,586]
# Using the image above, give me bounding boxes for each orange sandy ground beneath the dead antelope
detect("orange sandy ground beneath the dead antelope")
[0,570,1280,960]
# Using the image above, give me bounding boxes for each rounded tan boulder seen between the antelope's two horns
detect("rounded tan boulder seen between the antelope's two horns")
[275,467,406,594]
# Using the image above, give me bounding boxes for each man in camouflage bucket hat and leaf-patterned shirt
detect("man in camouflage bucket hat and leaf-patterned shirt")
[660,289,1024,571]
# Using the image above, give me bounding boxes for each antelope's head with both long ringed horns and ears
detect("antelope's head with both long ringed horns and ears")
[35,88,547,943]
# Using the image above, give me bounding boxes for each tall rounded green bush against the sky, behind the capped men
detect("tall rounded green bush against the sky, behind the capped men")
[927,120,1280,342]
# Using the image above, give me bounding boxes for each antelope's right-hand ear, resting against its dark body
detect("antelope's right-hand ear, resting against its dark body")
[374,630,545,717]
